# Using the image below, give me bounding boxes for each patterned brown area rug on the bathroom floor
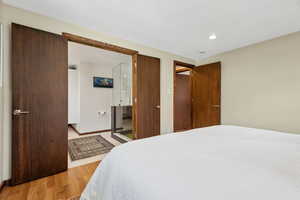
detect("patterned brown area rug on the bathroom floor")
[69,135,114,161]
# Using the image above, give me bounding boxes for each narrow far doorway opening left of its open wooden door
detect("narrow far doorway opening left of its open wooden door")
[173,61,194,132]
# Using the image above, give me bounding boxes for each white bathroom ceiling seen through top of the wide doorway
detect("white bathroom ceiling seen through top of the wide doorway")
[68,42,131,68]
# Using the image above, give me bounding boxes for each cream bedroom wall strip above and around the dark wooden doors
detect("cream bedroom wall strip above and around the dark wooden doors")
[1,2,195,179]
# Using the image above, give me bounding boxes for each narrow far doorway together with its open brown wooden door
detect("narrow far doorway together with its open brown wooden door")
[174,61,221,132]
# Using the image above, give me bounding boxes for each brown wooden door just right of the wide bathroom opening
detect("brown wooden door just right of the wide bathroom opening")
[134,55,160,139]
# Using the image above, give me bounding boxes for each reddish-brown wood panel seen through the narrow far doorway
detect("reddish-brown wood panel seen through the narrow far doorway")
[174,74,192,131]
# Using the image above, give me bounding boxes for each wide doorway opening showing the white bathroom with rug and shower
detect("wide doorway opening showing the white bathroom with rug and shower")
[68,34,135,168]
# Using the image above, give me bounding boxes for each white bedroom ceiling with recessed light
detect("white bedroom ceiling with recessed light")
[4,0,300,59]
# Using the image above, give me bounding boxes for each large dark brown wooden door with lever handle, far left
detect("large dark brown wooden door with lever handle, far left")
[11,24,68,185]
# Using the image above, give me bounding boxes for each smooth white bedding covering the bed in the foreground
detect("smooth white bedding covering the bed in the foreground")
[81,126,300,200]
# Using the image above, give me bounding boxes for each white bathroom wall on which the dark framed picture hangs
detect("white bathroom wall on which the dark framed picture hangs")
[75,63,113,133]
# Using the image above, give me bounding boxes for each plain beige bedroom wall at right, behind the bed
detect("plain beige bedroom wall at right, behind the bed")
[198,32,300,133]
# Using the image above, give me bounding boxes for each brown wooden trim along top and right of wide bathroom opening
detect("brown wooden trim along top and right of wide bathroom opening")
[62,32,139,139]
